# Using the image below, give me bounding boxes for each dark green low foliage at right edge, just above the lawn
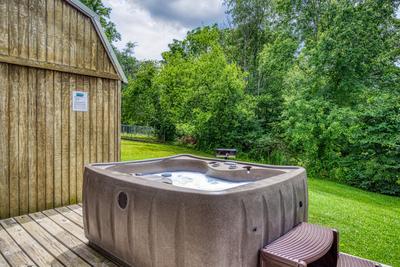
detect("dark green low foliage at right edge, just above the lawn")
[344,92,400,195]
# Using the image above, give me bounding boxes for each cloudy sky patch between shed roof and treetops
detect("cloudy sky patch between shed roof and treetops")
[103,0,227,60]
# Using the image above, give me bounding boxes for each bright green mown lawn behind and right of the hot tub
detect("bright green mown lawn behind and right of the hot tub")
[122,140,400,267]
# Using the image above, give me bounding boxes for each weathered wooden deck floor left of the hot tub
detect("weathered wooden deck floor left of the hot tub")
[0,205,116,266]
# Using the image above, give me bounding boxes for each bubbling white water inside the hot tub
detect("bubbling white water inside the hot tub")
[145,171,250,191]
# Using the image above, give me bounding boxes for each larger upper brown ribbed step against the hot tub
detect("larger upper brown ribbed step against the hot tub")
[260,223,338,267]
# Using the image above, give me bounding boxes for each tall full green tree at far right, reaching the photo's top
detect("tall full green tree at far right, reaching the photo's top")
[282,1,400,194]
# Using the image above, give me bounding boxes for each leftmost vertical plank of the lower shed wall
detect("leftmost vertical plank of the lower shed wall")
[0,63,10,218]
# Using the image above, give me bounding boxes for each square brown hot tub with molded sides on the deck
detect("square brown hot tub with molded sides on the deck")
[83,155,308,267]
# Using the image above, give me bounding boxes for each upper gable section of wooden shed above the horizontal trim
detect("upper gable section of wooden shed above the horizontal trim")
[0,0,120,79]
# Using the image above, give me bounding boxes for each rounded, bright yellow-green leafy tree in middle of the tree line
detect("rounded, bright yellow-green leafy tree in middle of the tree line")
[156,27,254,149]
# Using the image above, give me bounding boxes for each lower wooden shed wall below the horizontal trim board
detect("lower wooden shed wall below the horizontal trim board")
[0,63,121,218]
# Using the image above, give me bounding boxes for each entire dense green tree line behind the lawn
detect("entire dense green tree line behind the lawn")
[119,0,400,195]
